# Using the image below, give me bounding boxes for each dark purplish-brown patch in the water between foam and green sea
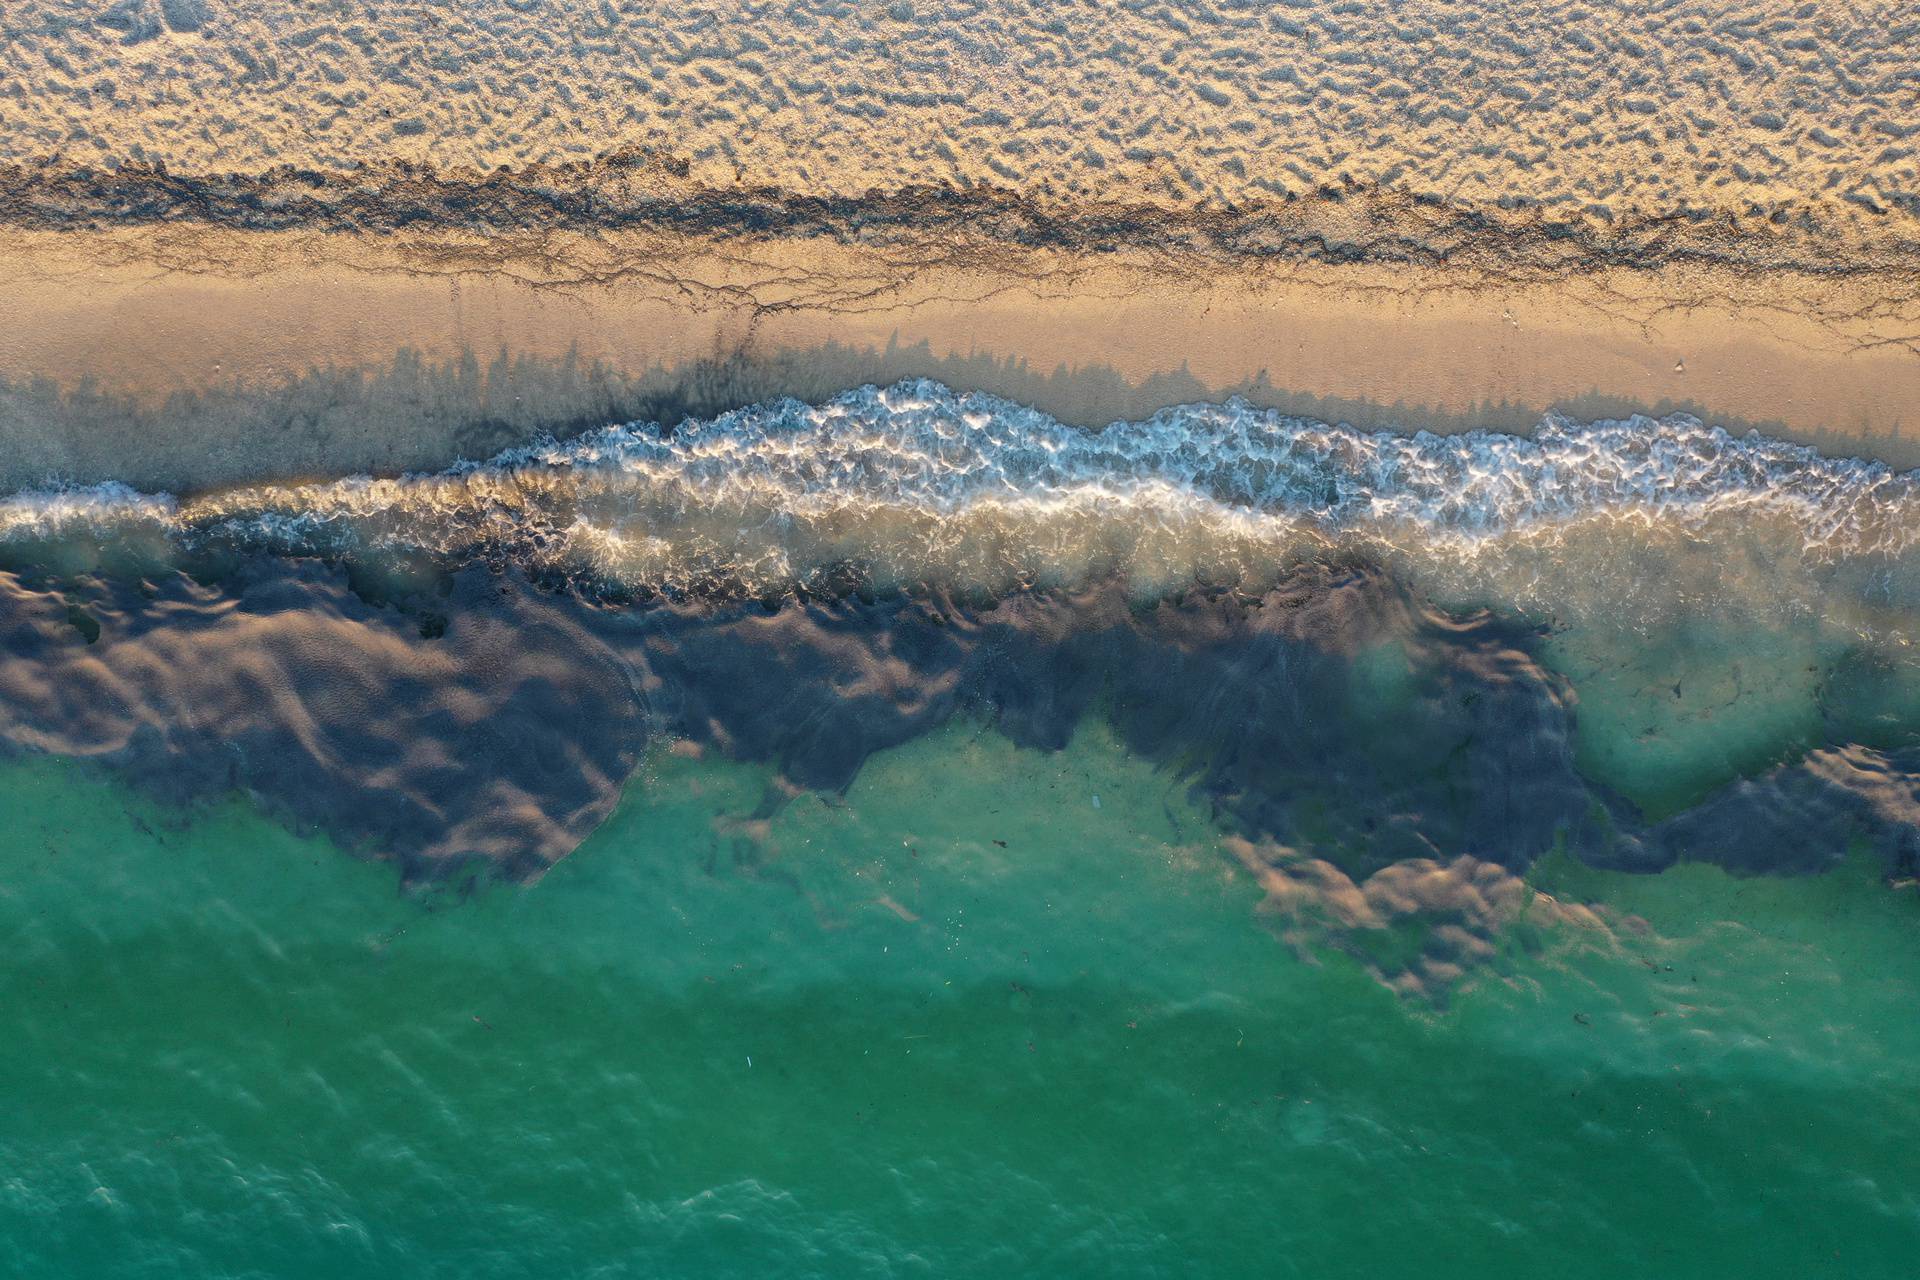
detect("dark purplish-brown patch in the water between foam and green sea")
[0,555,1920,879]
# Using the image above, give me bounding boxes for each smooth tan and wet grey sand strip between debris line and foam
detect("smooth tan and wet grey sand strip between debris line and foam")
[0,225,1920,491]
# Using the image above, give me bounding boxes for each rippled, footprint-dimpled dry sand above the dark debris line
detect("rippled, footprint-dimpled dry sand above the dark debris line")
[11,0,1920,217]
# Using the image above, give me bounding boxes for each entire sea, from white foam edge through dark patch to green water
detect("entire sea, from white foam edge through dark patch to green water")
[0,384,1920,1280]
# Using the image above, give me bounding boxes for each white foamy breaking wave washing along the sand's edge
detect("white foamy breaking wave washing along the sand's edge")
[11,382,1920,610]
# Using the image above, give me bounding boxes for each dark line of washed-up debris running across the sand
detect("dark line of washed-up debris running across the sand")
[0,150,1920,278]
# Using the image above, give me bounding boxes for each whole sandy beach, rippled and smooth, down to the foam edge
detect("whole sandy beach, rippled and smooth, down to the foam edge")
[0,0,1920,489]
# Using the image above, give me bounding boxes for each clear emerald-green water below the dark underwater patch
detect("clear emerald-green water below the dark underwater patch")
[0,725,1920,1278]
